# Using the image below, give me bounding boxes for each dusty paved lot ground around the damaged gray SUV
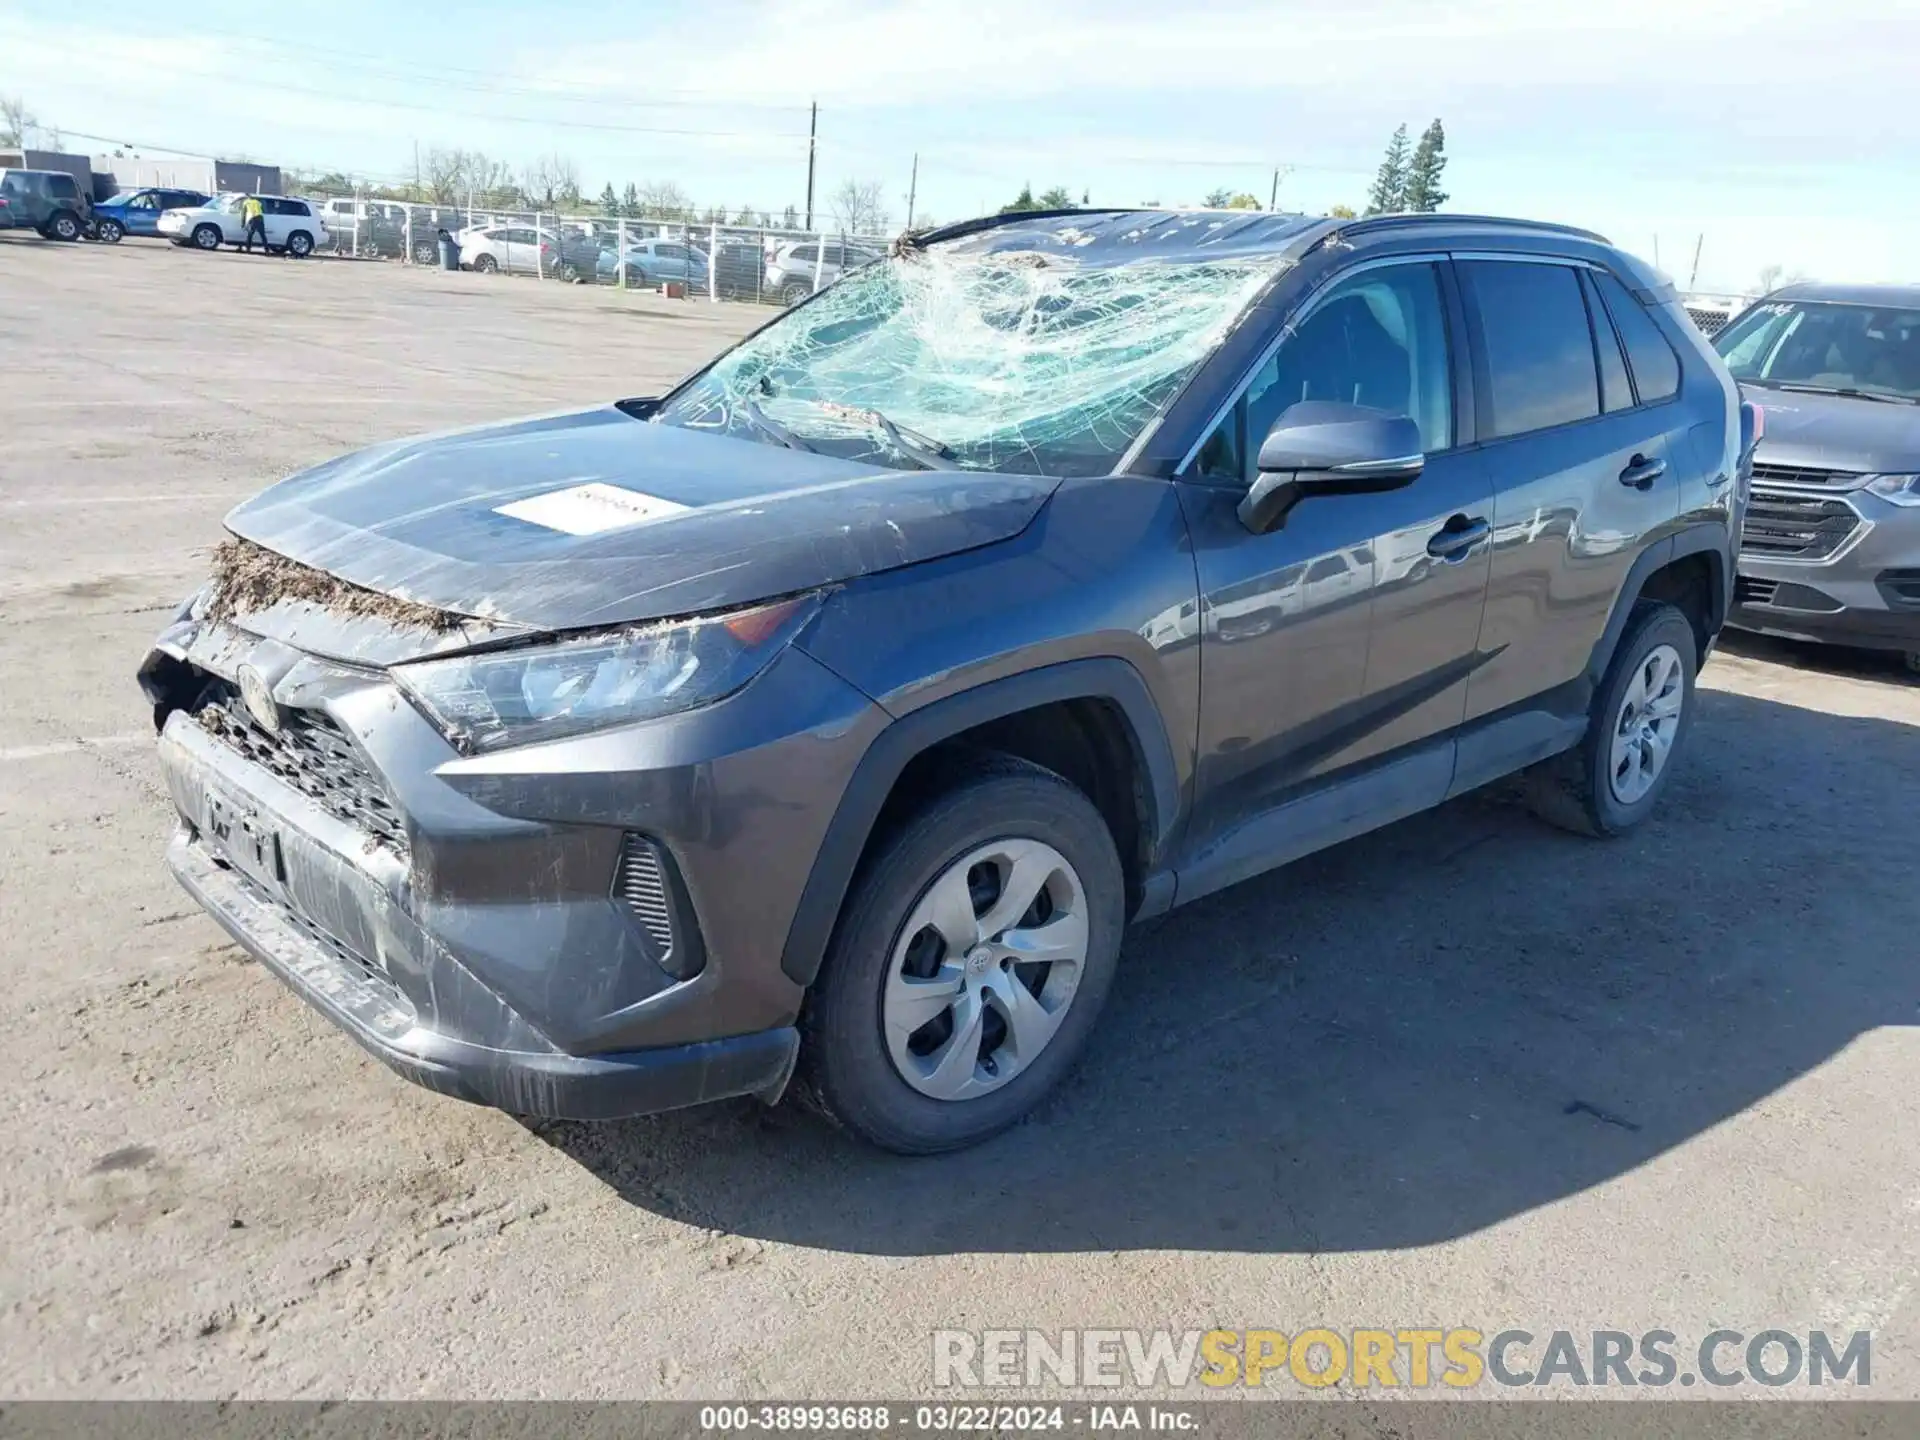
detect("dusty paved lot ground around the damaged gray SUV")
[0,238,1920,1398]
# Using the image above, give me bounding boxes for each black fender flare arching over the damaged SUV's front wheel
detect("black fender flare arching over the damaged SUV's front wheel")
[780,657,1181,985]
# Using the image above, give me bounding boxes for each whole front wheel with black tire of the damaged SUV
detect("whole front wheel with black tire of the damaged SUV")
[801,756,1125,1154]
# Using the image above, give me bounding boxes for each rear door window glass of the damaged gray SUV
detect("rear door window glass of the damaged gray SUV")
[1459,259,1599,438]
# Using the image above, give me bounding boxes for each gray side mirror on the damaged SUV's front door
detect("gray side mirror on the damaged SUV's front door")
[1240,399,1427,536]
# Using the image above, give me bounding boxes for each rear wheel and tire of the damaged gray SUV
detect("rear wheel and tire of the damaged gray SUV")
[1523,601,1699,837]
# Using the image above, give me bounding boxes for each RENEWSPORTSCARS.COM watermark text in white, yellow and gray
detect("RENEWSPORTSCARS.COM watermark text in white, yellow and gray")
[933,1327,1874,1390]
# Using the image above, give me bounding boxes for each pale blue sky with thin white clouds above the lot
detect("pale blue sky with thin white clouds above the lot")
[0,0,1920,290]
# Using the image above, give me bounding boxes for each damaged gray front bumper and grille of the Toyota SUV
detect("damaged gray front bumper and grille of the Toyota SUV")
[142,624,868,1119]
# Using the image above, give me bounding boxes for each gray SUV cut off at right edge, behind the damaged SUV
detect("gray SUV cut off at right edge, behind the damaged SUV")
[1713,284,1920,674]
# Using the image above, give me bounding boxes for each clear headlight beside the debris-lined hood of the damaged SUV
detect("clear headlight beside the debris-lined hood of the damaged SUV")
[392,595,820,753]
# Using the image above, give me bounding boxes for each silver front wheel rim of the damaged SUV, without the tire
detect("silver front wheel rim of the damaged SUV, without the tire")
[881,839,1089,1100]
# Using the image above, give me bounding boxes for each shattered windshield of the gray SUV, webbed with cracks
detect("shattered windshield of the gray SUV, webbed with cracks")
[655,246,1277,476]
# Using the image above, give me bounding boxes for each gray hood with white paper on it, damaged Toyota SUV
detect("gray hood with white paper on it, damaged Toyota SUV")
[227,405,1056,630]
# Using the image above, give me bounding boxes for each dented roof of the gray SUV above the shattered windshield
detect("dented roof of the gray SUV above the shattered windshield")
[916,209,1607,265]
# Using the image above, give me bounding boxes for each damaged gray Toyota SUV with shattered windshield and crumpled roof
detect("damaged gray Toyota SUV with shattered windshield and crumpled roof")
[140,211,1751,1152]
